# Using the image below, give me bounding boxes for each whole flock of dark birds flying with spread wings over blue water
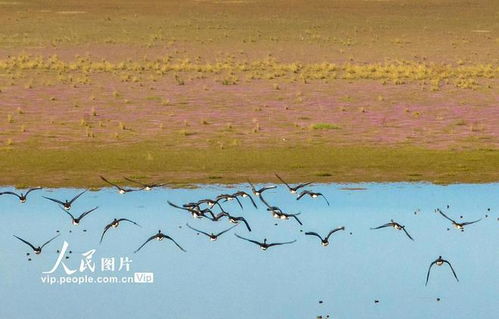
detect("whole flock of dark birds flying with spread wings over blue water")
[0,174,490,285]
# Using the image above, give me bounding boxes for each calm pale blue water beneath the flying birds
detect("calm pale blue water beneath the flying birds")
[0,183,499,319]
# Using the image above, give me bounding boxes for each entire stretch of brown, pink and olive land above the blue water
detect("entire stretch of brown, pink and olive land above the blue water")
[0,0,499,187]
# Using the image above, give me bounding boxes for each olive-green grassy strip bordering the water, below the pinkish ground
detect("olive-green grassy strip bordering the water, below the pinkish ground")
[0,143,499,187]
